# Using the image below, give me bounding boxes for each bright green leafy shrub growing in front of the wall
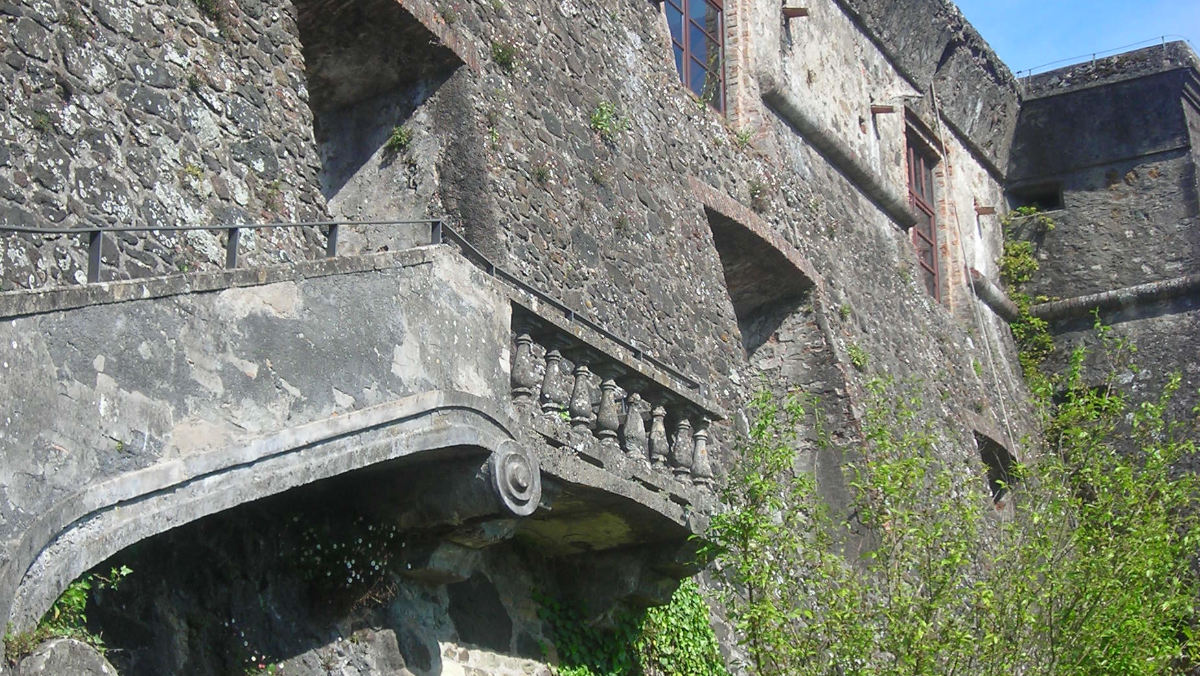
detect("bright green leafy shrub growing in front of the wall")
[707,357,1200,675]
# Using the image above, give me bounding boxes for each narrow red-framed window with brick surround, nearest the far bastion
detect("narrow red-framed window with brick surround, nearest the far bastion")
[905,131,942,301]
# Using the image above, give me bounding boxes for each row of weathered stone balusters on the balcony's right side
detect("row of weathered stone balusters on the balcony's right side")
[511,328,714,487]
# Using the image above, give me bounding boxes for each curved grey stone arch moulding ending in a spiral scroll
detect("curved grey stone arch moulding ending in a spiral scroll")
[0,390,530,630]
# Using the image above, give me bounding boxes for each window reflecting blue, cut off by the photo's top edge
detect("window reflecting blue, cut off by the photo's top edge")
[664,0,725,113]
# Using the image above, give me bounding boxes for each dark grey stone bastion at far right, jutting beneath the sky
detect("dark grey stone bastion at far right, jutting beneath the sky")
[1009,42,1200,437]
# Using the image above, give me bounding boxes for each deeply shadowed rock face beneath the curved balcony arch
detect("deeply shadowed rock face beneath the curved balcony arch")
[78,475,565,676]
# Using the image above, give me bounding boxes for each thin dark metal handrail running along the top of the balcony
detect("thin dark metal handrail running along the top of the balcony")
[0,219,704,395]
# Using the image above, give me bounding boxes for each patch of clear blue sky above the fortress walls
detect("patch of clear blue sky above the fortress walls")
[955,0,1200,73]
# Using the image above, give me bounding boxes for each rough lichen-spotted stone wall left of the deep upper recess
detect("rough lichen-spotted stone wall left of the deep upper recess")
[0,0,326,288]
